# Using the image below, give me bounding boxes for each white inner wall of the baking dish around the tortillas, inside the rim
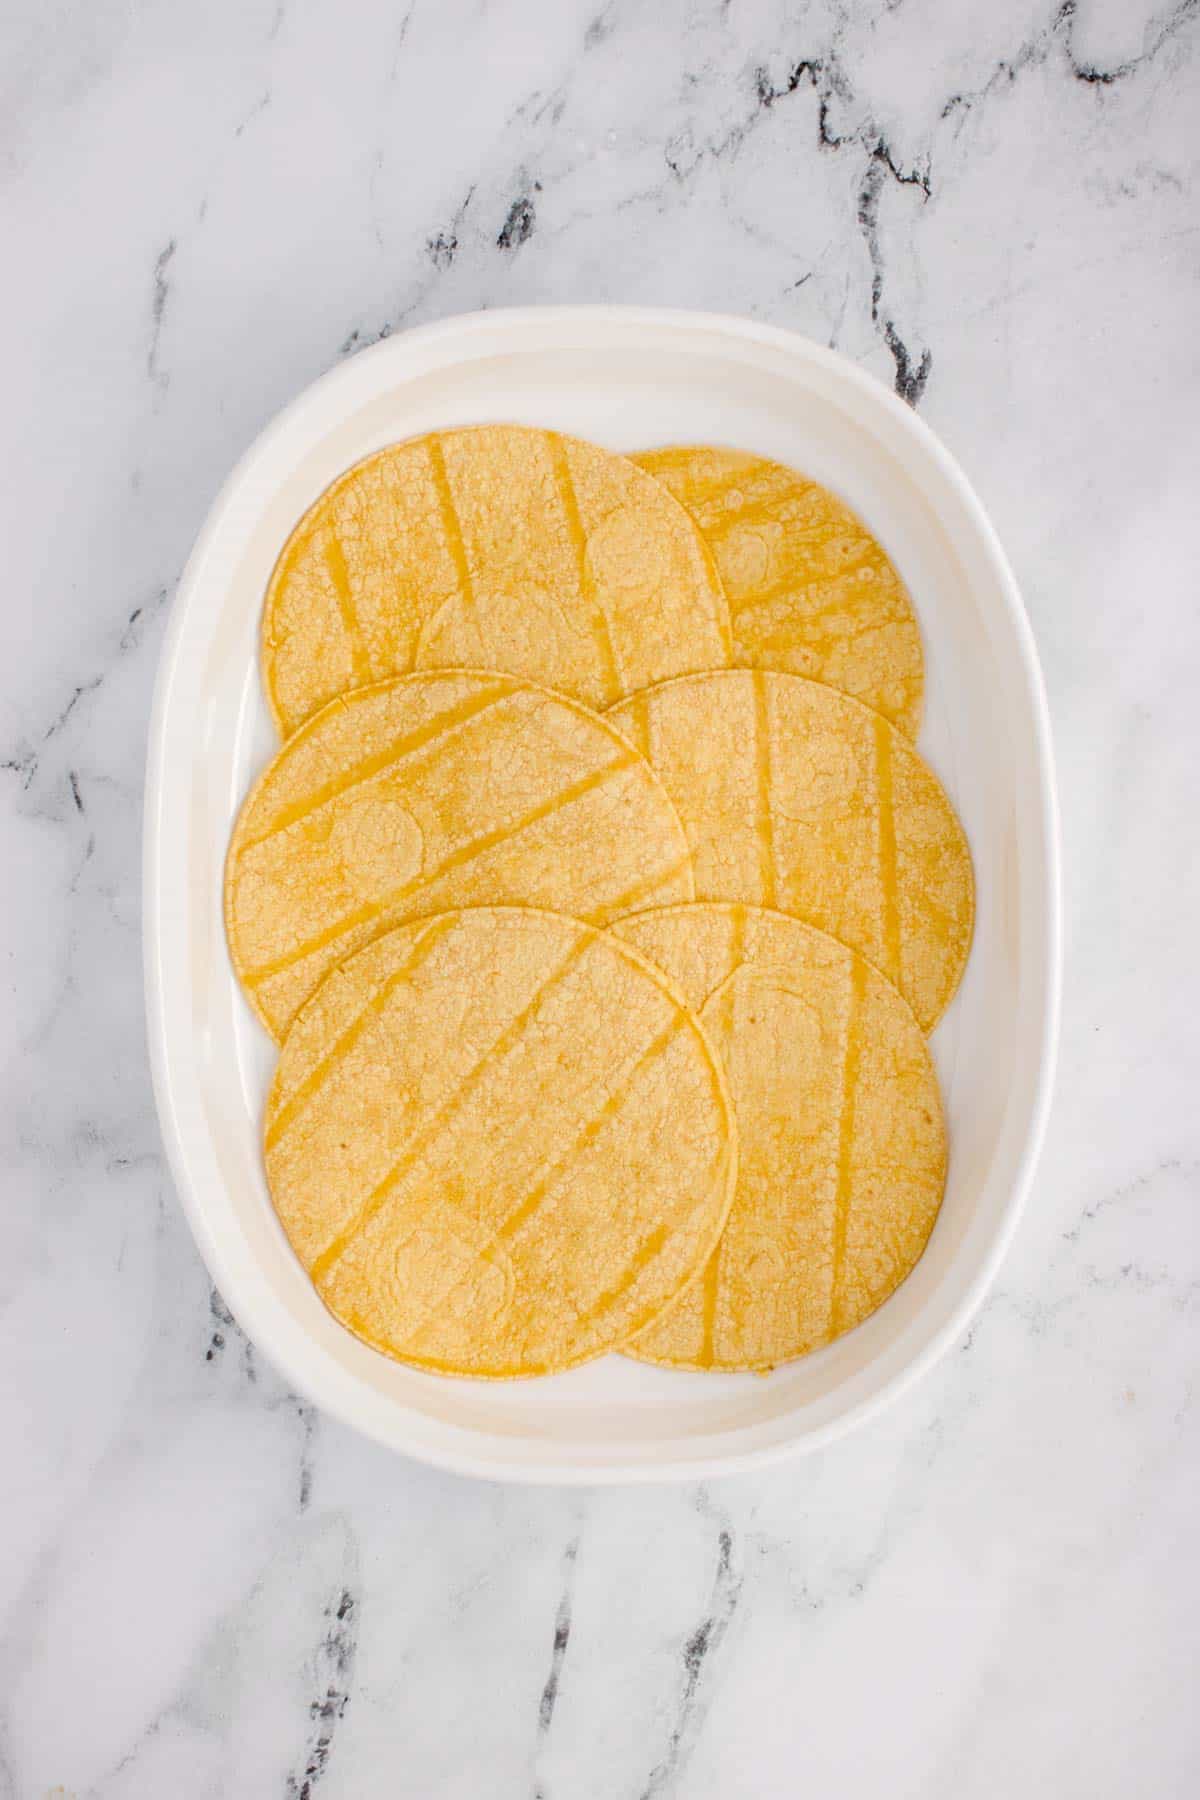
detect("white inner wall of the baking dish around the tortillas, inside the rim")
[193,331,1018,1442]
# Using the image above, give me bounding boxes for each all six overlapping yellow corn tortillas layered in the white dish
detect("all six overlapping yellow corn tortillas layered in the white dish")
[225,425,973,1377]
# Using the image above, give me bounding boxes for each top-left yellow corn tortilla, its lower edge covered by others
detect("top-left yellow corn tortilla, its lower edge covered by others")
[263,425,732,738]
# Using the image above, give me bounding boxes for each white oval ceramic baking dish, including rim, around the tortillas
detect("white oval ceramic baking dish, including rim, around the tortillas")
[146,306,1060,1481]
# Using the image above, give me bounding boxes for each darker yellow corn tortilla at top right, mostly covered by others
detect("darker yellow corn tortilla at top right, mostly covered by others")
[633,445,925,738]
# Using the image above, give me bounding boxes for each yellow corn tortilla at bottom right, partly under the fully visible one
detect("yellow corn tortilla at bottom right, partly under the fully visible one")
[612,905,946,1370]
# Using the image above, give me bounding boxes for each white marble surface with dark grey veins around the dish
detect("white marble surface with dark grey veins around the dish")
[0,0,1200,1800]
